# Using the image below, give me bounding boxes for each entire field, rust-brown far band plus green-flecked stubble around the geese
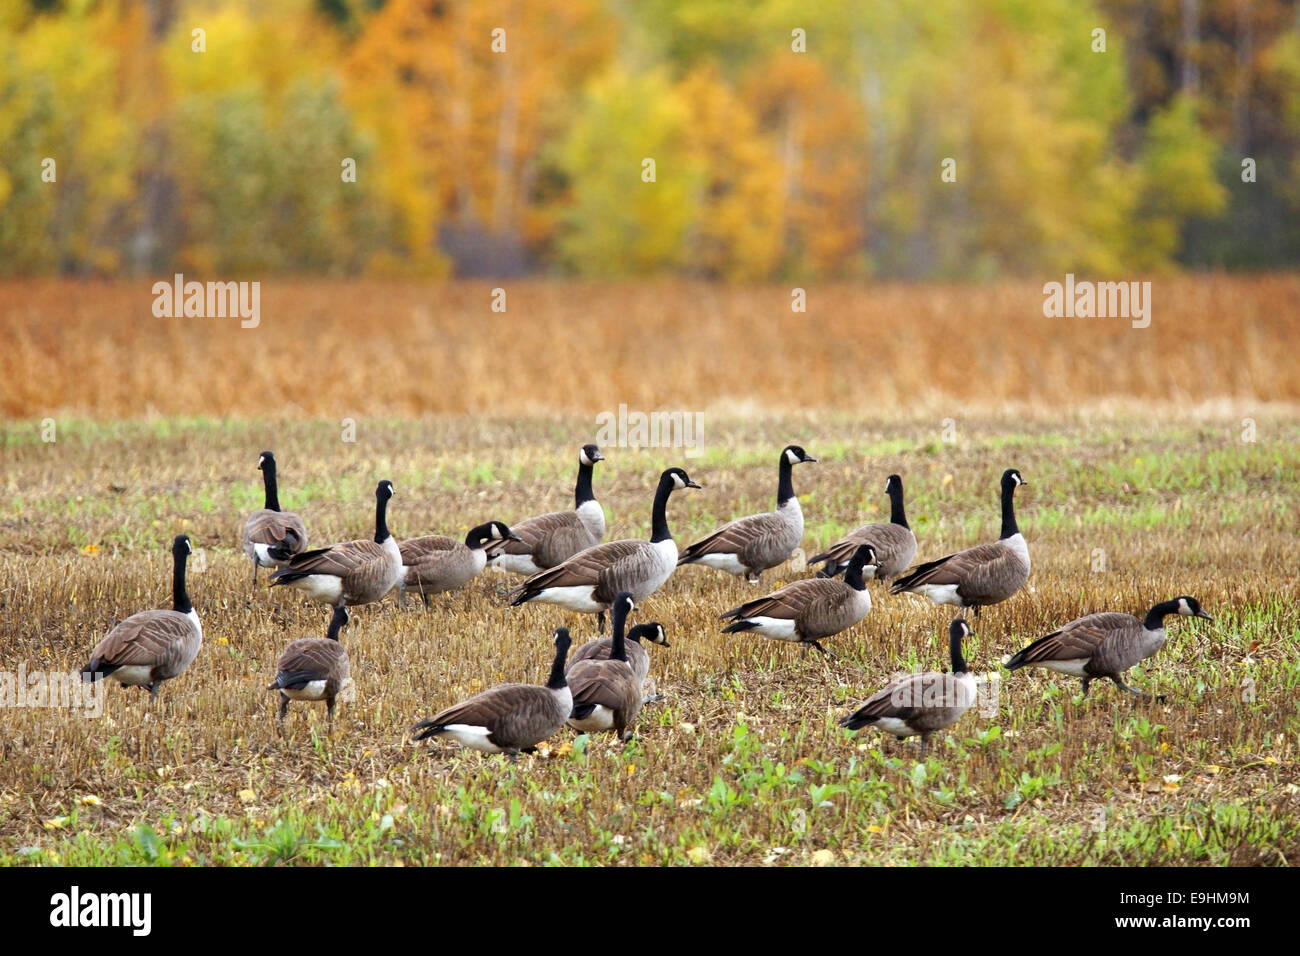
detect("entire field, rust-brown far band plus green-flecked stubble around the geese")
[0,277,1300,865]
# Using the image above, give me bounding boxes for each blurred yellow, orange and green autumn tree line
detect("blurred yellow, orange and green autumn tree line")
[0,0,1300,280]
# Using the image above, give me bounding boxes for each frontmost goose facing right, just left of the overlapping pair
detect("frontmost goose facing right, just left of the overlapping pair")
[412,627,573,760]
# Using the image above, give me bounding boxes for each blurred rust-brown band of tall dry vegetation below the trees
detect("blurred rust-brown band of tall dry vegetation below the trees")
[0,276,1300,419]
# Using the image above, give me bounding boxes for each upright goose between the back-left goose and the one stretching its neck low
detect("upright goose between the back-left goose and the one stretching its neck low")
[270,481,403,607]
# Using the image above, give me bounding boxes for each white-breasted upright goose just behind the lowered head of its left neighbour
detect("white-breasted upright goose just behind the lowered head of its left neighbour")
[488,445,605,575]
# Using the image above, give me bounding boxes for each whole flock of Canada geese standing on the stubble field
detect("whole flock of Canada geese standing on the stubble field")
[82,445,1210,760]
